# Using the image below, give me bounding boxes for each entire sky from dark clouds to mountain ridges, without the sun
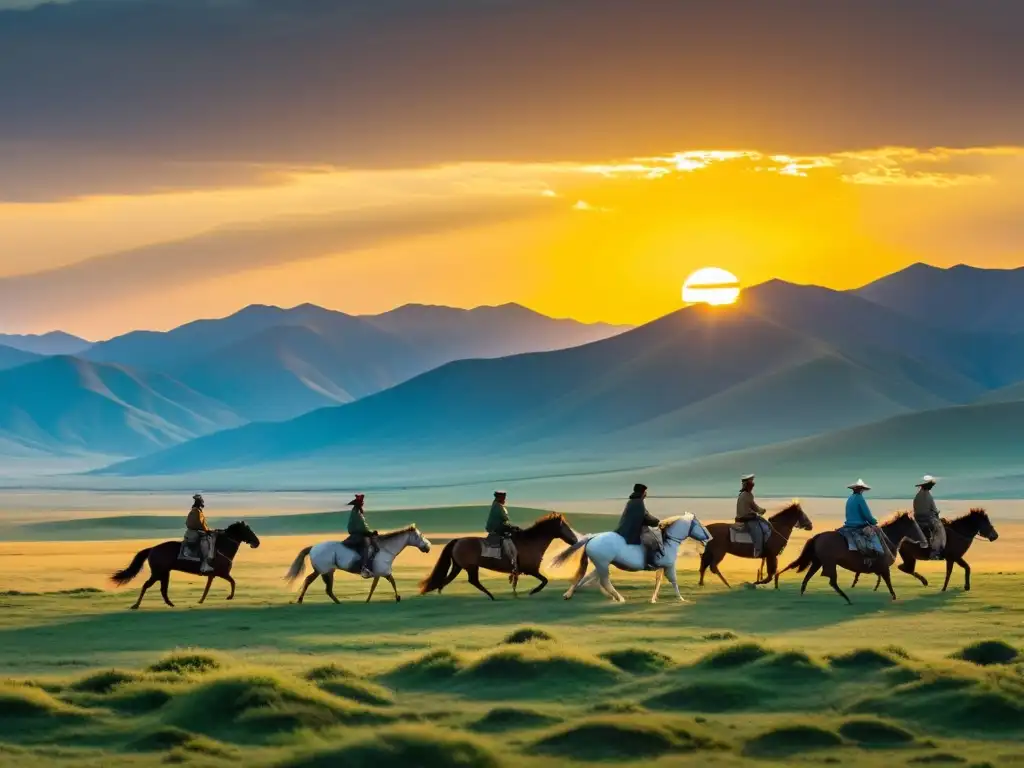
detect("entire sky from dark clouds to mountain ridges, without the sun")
[0,0,1024,339]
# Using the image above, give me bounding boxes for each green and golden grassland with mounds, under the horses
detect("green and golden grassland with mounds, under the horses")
[0,510,1024,768]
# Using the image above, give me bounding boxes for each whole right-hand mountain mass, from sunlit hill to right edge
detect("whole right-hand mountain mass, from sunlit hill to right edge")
[97,265,1024,495]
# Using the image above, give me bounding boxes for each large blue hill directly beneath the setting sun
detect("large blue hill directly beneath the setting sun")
[96,283,990,474]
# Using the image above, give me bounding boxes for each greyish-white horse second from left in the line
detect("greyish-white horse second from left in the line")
[285,524,430,603]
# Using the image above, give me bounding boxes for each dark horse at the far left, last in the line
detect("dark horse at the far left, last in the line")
[111,520,259,610]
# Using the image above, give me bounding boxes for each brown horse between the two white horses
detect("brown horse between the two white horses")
[420,512,579,600]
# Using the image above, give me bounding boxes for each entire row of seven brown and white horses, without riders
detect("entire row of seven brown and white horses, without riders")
[111,502,998,609]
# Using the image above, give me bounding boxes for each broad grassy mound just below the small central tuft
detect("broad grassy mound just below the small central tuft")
[458,647,620,690]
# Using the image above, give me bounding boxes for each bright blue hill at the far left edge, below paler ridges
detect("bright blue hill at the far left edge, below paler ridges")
[0,356,242,457]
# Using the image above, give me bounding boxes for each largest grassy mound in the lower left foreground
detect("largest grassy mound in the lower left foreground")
[164,673,385,741]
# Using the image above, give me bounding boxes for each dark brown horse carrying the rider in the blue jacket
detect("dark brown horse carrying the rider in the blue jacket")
[775,512,928,604]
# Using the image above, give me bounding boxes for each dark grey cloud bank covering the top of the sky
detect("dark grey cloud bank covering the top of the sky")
[0,0,1024,197]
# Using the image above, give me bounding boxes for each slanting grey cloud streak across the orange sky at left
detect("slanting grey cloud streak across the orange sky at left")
[0,197,564,328]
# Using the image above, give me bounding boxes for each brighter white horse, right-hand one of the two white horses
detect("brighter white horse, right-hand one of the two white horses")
[553,512,712,603]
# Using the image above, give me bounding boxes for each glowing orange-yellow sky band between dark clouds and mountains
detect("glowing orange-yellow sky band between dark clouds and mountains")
[0,147,1024,338]
